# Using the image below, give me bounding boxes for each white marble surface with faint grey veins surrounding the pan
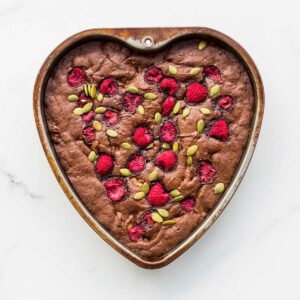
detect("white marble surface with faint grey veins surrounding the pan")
[0,0,300,300]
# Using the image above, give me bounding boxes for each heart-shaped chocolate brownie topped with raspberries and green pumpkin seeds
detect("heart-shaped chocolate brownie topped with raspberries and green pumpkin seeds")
[45,39,253,259]
